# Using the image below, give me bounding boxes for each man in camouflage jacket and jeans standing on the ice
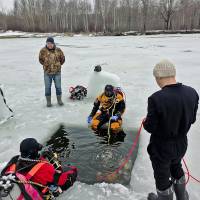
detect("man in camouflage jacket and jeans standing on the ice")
[39,37,65,107]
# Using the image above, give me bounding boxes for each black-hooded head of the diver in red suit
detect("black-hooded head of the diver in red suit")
[20,138,43,159]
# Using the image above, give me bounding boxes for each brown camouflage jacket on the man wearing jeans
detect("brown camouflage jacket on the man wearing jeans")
[39,47,65,74]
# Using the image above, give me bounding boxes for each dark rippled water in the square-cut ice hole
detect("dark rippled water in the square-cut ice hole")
[47,125,138,185]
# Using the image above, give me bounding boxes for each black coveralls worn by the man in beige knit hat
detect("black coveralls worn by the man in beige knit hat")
[144,83,199,191]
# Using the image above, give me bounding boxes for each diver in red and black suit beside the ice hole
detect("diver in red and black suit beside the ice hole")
[1,138,77,200]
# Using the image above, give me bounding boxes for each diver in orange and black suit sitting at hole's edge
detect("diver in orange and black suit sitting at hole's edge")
[87,85,125,133]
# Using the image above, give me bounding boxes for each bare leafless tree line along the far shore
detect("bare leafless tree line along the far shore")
[0,0,200,33]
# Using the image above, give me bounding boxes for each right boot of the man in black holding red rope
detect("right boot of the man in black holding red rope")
[173,176,189,200]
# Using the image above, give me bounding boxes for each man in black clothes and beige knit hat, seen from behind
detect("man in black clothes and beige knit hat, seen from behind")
[144,60,199,200]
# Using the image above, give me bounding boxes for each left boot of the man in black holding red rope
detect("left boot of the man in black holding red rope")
[147,187,173,200]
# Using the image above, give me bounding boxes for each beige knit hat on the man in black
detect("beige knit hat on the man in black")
[153,60,176,78]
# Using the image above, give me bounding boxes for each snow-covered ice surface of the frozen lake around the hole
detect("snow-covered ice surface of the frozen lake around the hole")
[0,34,200,200]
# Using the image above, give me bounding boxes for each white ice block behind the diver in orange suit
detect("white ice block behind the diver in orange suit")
[87,71,121,99]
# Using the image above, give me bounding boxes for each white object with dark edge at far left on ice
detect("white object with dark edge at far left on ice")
[0,87,13,124]
